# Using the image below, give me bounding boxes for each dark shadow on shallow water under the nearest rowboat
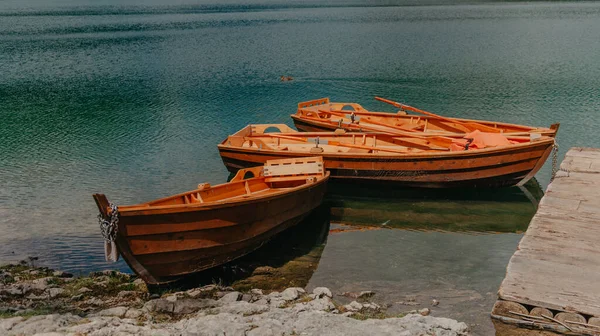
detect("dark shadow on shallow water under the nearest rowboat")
[153,205,330,291]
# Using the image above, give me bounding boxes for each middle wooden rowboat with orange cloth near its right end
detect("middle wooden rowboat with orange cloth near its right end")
[218,124,554,188]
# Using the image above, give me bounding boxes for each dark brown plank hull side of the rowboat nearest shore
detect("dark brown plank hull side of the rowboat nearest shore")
[116,178,327,284]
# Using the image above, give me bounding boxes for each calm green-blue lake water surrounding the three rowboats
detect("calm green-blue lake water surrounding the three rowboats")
[0,0,600,334]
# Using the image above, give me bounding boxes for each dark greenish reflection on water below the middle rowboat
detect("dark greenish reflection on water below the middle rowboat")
[326,180,543,232]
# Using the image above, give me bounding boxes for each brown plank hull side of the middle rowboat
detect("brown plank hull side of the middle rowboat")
[219,140,553,188]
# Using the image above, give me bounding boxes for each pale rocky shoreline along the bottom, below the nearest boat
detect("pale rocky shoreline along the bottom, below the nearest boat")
[0,263,469,336]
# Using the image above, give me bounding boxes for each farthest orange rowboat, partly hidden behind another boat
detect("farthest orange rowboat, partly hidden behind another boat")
[292,97,560,137]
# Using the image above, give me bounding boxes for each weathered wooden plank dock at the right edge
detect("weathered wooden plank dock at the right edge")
[492,148,600,335]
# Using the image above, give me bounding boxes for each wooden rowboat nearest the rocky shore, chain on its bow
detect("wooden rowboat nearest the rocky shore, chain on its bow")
[93,157,329,284]
